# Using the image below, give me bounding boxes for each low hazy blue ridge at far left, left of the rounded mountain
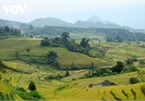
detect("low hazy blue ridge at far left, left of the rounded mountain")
[0,19,30,29]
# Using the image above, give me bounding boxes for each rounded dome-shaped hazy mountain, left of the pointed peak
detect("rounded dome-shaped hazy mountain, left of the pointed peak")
[29,17,72,27]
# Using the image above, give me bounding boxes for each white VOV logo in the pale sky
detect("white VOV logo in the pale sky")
[3,5,27,14]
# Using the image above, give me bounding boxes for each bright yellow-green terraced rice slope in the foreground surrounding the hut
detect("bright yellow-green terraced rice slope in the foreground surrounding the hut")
[1,62,145,100]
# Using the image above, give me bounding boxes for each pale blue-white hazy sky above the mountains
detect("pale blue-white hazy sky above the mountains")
[0,0,145,29]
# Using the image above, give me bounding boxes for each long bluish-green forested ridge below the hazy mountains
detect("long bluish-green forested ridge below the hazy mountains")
[26,26,145,41]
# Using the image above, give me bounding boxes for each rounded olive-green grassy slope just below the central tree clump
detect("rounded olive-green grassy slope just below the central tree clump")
[21,46,111,66]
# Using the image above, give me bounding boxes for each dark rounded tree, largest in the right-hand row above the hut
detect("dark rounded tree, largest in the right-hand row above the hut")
[112,61,125,73]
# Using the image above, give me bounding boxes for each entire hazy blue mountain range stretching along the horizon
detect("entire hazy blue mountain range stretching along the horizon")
[0,15,144,30]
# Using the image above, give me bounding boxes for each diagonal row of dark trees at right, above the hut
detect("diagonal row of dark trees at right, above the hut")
[82,56,145,78]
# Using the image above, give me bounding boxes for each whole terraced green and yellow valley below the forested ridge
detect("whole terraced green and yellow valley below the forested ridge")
[0,34,145,100]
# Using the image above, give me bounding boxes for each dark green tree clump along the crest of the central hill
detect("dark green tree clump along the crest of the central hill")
[40,32,91,55]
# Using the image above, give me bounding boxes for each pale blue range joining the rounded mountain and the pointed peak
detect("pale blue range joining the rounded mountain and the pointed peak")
[29,15,131,29]
